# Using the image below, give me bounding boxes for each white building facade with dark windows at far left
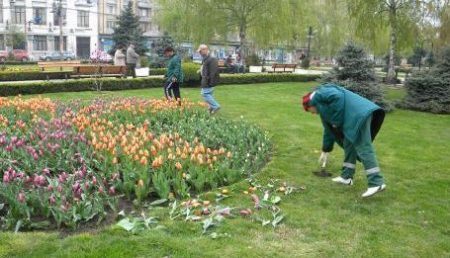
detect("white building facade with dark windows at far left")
[0,0,98,60]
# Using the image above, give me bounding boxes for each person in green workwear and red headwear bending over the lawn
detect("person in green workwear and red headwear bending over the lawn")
[303,84,386,197]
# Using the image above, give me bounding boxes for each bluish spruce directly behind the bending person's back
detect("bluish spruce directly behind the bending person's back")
[322,43,392,111]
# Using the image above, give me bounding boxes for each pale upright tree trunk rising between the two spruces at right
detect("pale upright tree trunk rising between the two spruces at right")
[386,0,397,84]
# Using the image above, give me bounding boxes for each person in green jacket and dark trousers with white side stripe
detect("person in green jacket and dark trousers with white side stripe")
[164,47,183,104]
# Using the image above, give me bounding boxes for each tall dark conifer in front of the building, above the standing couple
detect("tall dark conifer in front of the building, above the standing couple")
[110,1,148,55]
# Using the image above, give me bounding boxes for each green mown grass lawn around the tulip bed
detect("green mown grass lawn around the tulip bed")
[0,83,450,258]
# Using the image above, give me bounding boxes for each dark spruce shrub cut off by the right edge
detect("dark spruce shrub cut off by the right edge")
[399,48,450,114]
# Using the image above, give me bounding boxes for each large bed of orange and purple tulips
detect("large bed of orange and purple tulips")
[0,97,271,230]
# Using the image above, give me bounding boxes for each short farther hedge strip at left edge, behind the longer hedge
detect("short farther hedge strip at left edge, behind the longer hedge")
[0,71,72,81]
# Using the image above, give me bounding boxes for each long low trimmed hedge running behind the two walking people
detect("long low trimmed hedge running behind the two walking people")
[0,74,319,96]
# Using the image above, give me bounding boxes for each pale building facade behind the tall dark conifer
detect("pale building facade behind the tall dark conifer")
[98,0,162,51]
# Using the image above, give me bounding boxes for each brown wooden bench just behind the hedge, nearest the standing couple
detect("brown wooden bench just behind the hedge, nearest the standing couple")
[71,65,127,78]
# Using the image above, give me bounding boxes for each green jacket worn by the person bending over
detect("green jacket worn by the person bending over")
[310,84,384,152]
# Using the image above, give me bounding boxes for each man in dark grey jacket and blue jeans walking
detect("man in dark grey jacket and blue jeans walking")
[197,44,220,114]
